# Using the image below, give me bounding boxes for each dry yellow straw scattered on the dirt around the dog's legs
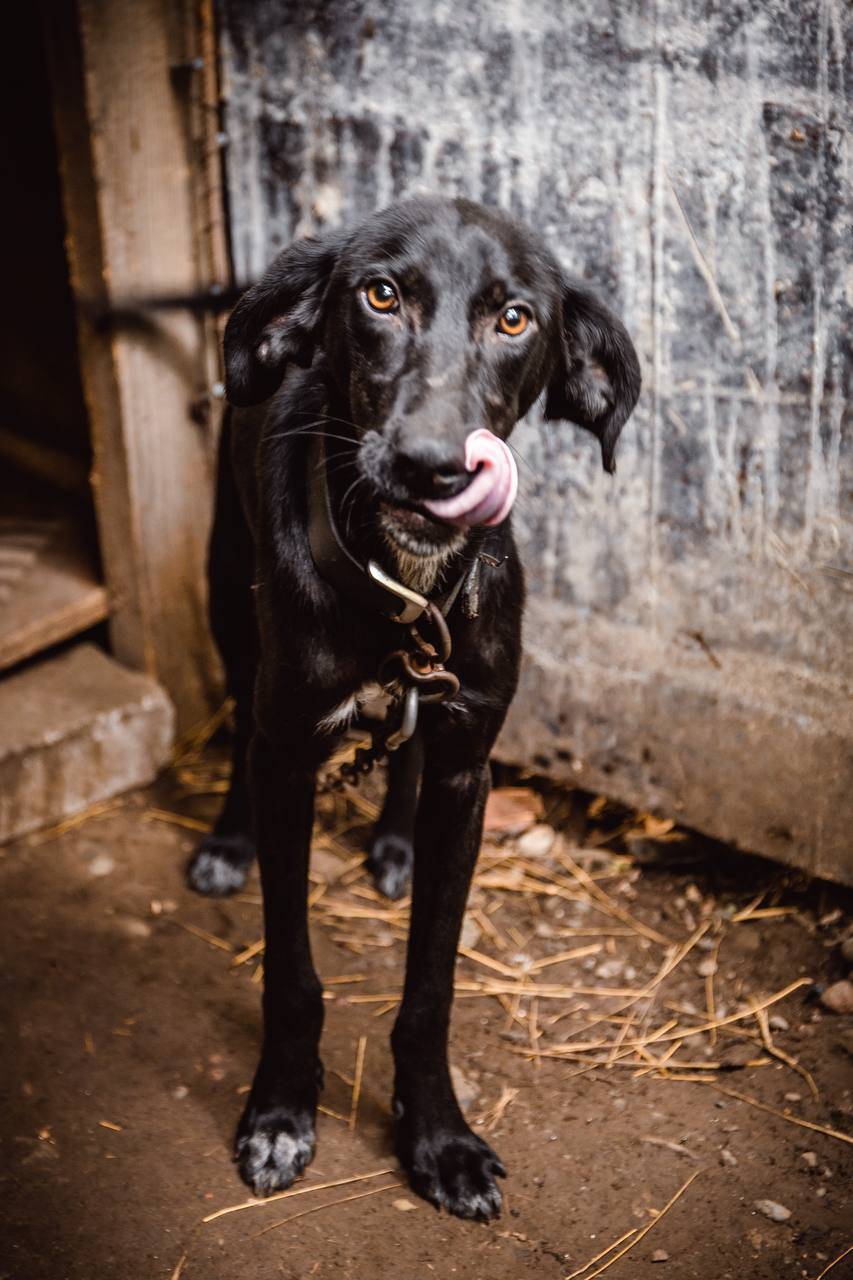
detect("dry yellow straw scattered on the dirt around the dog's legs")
[150,747,853,1254]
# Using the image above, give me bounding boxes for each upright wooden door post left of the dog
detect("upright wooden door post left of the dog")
[42,0,225,728]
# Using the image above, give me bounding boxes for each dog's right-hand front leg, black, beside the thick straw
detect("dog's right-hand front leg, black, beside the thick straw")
[392,742,505,1220]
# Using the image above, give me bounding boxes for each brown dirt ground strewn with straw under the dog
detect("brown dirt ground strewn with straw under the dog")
[0,755,853,1280]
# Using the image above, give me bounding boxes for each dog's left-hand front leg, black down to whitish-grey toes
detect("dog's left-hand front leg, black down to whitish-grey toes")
[236,730,323,1196]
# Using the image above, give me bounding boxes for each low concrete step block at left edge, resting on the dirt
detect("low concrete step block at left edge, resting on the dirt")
[0,644,174,844]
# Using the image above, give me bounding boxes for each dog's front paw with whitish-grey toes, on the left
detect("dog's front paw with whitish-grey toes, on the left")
[234,1107,315,1196]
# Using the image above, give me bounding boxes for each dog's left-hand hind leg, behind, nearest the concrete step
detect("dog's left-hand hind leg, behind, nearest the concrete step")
[187,421,259,897]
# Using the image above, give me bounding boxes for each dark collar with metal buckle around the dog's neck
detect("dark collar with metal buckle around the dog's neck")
[307,431,468,626]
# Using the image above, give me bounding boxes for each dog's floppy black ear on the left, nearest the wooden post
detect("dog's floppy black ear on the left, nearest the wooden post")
[224,232,346,408]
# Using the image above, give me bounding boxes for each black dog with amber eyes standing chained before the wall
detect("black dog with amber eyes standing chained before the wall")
[190,198,640,1219]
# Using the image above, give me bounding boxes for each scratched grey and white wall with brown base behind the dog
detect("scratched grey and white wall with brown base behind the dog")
[220,0,853,879]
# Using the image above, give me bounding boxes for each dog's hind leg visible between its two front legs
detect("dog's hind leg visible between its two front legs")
[368,733,424,899]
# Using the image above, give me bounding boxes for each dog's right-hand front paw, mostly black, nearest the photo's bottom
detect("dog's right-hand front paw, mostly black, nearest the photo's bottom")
[397,1126,506,1222]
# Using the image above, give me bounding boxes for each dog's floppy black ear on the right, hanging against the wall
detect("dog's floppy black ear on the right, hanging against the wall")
[544,279,640,472]
